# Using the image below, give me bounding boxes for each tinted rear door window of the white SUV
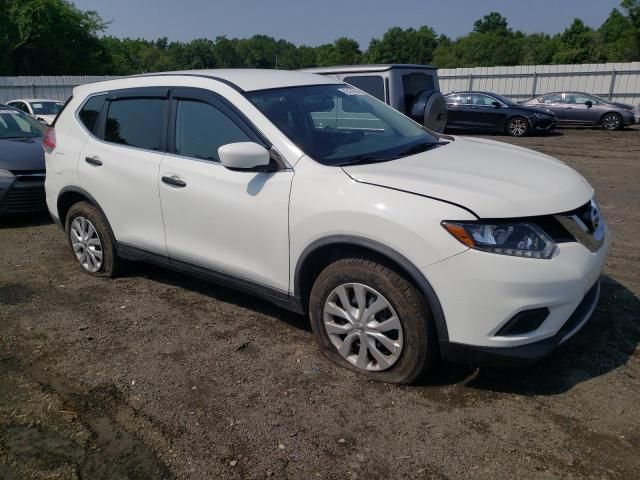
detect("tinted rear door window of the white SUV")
[104,98,166,150]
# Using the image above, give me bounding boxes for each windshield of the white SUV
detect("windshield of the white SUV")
[247,84,438,165]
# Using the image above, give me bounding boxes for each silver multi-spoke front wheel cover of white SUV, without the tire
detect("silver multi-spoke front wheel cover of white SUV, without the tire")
[323,283,403,371]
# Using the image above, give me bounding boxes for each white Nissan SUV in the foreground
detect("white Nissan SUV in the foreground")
[44,70,608,383]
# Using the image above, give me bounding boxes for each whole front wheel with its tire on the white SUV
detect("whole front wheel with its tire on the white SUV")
[309,258,440,384]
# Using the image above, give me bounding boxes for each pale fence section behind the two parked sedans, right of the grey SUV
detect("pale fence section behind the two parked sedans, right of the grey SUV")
[438,62,640,105]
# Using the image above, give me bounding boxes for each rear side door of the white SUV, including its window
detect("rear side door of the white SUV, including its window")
[78,88,169,255]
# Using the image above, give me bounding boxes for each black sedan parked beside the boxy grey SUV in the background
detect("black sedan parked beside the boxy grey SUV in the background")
[445,92,557,137]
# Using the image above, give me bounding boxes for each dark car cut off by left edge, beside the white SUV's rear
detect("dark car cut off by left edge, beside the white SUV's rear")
[0,105,47,215]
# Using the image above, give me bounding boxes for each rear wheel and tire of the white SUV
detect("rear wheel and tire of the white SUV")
[65,202,120,277]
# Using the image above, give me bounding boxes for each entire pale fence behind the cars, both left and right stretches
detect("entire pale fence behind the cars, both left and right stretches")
[0,62,640,105]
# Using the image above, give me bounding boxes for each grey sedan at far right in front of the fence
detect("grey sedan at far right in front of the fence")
[522,92,636,130]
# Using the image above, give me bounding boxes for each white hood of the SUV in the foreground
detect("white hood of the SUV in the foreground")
[344,137,593,218]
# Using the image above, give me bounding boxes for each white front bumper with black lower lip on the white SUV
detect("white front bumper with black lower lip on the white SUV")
[422,229,610,364]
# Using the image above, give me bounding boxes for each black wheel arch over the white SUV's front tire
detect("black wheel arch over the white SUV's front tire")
[294,235,449,342]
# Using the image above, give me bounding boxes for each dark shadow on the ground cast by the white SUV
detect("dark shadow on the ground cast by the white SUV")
[124,253,640,395]
